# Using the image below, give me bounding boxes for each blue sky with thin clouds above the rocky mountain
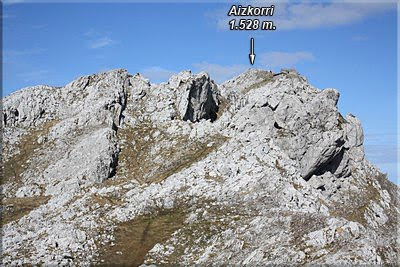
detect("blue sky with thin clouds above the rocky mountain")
[2,0,398,184]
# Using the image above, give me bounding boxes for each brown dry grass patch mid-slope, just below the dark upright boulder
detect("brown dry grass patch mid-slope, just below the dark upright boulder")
[117,123,226,184]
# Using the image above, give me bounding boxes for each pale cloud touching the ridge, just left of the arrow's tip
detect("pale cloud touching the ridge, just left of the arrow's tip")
[193,62,250,83]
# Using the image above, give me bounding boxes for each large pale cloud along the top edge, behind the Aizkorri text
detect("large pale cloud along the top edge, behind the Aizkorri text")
[217,1,396,30]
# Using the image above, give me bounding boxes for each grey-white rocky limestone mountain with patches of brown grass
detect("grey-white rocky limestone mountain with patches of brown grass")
[1,69,399,266]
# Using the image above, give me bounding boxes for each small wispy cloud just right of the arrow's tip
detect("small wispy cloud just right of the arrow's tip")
[256,51,315,69]
